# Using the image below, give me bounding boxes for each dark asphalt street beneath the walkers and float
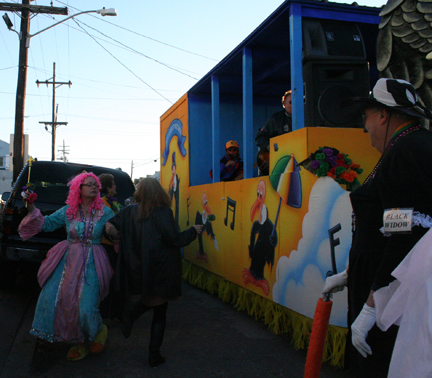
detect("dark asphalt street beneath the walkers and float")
[0,283,351,378]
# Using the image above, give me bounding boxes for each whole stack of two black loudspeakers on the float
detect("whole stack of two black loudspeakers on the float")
[302,19,369,127]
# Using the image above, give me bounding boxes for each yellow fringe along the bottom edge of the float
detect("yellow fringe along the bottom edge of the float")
[183,259,348,368]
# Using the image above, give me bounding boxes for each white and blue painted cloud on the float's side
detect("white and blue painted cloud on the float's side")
[273,177,352,327]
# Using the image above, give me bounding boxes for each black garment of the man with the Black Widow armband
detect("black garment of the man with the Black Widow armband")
[347,125,432,377]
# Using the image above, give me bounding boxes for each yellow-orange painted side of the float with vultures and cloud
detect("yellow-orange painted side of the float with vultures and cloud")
[161,99,377,327]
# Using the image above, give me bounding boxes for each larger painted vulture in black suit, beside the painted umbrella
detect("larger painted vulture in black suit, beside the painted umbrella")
[243,181,277,295]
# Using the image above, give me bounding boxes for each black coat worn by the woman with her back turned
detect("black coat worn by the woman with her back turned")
[110,204,197,298]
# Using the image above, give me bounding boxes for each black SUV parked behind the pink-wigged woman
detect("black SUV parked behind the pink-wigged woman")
[0,161,135,288]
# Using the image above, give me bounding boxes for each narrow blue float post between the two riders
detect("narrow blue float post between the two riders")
[241,47,254,178]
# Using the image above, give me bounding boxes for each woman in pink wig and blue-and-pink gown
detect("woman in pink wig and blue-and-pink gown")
[19,172,114,361]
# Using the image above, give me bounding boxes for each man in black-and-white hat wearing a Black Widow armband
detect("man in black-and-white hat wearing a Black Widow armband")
[323,79,432,378]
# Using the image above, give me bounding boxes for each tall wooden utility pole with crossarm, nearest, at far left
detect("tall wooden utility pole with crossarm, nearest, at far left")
[0,0,68,181]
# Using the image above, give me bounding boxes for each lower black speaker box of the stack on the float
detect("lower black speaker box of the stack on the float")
[303,60,369,127]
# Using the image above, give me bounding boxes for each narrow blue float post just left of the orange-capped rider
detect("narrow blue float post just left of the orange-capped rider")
[211,75,221,182]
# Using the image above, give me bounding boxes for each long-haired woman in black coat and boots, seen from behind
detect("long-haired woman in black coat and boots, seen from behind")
[106,178,202,367]
